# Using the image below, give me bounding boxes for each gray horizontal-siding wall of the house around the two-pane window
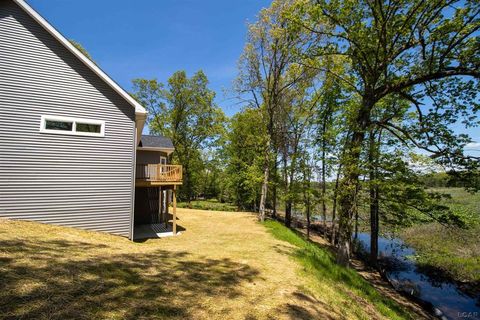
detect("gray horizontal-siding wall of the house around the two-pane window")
[0,0,135,236]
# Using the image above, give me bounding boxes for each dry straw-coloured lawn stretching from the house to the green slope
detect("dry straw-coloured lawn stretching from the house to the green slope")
[0,209,412,319]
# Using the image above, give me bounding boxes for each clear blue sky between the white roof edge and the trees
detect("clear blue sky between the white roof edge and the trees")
[28,0,270,115]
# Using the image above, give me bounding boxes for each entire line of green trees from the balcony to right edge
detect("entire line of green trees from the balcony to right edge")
[134,0,480,264]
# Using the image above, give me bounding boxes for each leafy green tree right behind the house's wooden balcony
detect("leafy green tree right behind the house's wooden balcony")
[133,71,225,202]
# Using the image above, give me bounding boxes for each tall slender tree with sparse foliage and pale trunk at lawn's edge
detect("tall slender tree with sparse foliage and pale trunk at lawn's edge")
[235,0,316,220]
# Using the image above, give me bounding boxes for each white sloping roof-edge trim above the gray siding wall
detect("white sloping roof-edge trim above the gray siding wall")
[13,0,147,116]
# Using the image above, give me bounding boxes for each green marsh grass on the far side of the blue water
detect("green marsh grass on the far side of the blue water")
[400,188,480,283]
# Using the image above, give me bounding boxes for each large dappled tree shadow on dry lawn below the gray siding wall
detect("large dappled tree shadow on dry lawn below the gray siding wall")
[0,239,258,319]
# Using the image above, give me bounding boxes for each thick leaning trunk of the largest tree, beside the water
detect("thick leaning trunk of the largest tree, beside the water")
[337,97,375,266]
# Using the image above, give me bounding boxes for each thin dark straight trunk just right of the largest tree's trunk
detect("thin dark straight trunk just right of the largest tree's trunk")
[368,130,380,266]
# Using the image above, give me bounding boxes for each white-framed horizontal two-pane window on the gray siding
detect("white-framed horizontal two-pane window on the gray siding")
[40,116,105,137]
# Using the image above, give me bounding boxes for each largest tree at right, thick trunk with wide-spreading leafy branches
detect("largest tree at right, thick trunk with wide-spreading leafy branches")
[290,0,480,265]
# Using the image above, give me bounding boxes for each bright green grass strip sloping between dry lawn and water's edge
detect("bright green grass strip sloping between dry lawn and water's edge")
[265,221,411,319]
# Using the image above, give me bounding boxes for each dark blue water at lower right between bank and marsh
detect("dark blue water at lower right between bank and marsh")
[358,233,480,319]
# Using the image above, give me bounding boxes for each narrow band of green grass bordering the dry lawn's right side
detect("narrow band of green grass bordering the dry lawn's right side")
[265,220,411,319]
